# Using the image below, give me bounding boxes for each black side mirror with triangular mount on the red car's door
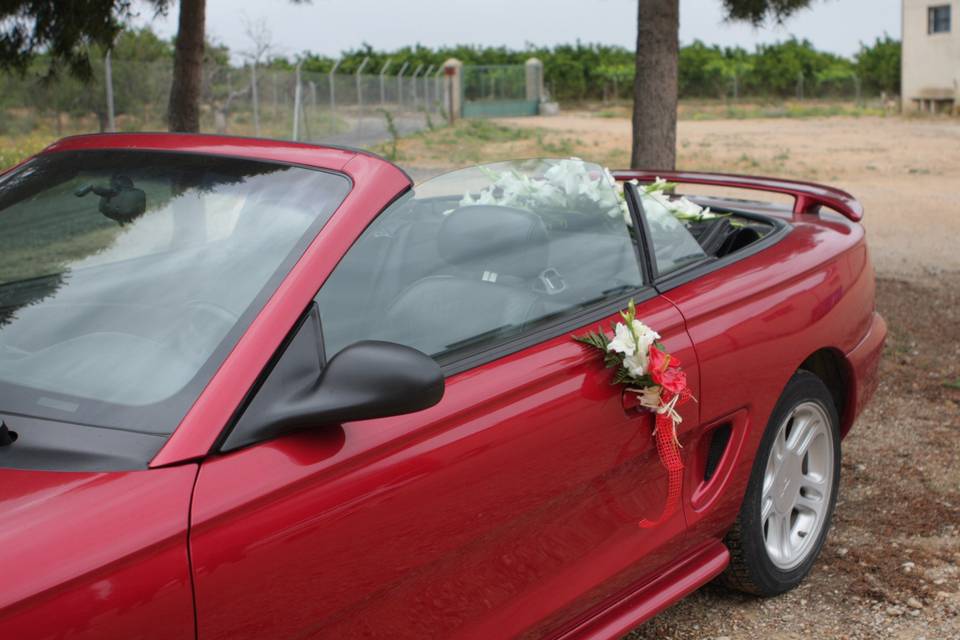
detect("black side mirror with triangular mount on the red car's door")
[221,307,444,451]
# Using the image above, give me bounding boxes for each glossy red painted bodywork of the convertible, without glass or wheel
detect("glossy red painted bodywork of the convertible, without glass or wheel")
[0,134,886,640]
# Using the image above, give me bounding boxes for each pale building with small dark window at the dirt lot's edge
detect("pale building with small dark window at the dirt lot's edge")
[900,0,960,112]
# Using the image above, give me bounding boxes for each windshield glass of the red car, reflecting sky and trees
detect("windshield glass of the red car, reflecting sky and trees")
[0,150,350,434]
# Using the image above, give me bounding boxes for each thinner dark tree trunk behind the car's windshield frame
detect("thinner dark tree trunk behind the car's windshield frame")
[167,0,206,133]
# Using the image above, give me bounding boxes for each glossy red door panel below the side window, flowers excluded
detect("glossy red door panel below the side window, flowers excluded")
[191,298,697,638]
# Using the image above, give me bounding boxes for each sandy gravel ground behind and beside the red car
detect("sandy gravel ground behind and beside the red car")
[402,113,960,640]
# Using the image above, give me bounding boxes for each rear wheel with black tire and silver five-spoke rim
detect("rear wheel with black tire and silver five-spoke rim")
[720,370,840,596]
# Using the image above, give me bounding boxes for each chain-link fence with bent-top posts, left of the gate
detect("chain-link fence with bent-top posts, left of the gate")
[0,60,446,146]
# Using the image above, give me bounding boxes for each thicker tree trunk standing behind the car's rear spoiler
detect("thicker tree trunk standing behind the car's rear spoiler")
[630,0,680,171]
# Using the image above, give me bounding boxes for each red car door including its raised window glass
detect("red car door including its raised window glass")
[190,161,699,638]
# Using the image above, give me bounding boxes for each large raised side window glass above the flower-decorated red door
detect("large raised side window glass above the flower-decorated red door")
[317,159,643,359]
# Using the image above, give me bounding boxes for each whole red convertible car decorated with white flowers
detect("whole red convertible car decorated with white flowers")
[0,134,886,640]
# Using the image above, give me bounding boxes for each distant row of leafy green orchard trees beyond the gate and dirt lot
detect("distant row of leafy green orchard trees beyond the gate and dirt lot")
[267,37,900,101]
